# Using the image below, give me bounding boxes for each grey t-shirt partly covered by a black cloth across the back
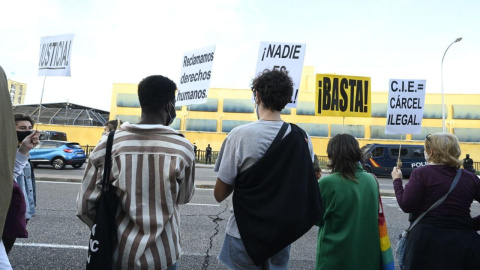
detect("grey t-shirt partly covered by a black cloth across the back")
[214,120,314,239]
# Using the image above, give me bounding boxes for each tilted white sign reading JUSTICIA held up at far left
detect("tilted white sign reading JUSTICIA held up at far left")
[38,34,74,76]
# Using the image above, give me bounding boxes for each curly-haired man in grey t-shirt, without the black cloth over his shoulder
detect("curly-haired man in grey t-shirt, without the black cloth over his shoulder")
[214,71,314,269]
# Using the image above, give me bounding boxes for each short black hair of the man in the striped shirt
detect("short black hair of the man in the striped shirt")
[138,75,177,113]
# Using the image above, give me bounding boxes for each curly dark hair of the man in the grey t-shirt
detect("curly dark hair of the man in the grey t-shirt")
[252,69,293,111]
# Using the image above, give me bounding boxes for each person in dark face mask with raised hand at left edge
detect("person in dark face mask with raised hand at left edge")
[2,114,38,254]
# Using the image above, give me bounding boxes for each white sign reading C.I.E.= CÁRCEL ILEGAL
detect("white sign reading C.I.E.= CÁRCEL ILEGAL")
[385,79,427,134]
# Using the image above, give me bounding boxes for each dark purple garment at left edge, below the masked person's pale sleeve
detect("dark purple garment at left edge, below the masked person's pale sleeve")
[3,181,28,238]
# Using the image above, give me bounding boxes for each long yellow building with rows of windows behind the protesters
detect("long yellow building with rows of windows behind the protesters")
[110,67,480,160]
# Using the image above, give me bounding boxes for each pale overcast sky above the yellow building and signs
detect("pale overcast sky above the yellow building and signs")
[0,0,480,110]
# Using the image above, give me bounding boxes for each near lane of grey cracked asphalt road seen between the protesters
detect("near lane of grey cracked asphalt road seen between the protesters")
[9,182,480,269]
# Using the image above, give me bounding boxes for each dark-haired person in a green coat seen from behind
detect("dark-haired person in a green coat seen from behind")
[316,134,381,270]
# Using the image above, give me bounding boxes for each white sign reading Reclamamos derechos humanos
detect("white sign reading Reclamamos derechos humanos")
[175,45,215,106]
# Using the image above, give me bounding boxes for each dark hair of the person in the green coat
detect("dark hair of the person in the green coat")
[327,134,363,182]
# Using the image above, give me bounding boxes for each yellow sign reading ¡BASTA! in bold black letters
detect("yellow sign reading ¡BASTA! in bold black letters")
[315,74,372,117]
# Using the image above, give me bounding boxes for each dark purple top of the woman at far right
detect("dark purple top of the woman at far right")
[393,165,480,231]
